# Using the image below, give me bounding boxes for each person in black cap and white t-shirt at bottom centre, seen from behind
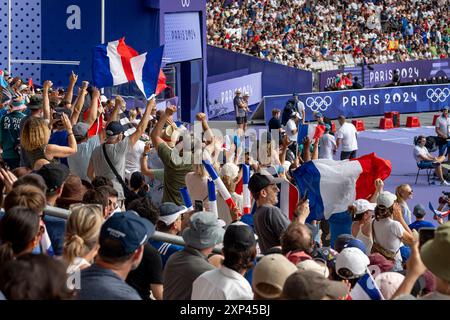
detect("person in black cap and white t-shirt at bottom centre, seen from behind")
[192,224,256,300]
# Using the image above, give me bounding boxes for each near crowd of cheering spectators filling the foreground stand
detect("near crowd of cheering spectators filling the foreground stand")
[0,68,450,300]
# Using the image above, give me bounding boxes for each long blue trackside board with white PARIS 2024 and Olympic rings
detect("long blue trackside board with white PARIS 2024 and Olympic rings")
[264,84,450,123]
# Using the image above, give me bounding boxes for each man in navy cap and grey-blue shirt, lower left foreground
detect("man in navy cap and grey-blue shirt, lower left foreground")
[78,211,155,300]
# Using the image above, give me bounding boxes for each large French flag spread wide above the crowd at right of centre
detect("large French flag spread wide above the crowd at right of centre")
[293,153,392,220]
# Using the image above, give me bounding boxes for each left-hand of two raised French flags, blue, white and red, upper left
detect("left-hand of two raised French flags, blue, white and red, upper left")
[92,38,139,88]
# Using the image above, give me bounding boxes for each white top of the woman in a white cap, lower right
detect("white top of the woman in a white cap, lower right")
[372,218,405,252]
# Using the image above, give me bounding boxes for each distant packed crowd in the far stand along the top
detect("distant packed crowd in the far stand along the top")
[207,0,450,70]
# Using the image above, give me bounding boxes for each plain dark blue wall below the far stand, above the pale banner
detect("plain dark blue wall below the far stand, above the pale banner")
[206,46,312,96]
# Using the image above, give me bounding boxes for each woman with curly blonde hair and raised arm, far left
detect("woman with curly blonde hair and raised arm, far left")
[20,113,77,170]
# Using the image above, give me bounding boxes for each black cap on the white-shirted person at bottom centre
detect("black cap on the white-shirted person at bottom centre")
[223,224,256,251]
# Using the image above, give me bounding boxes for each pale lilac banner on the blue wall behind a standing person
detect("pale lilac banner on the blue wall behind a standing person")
[208,72,262,119]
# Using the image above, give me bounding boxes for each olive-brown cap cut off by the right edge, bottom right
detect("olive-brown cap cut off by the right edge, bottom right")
[420,221,450,282]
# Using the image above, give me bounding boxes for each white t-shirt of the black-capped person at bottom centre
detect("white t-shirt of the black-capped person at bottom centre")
[191,266,253,300]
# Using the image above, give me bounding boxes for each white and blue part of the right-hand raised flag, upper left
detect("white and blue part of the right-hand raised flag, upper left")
[131,46,164,100]
